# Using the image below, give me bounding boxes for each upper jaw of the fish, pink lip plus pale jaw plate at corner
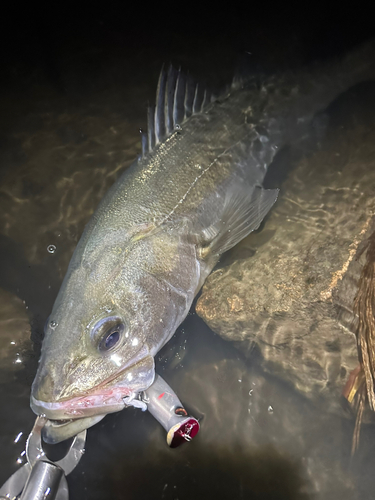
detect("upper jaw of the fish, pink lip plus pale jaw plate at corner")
[30,355,155,425]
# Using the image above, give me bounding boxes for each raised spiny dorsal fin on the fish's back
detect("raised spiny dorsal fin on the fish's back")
[142,65,213,156]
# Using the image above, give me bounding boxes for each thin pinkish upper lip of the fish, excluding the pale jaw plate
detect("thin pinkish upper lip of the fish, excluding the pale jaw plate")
[30,354,155,421]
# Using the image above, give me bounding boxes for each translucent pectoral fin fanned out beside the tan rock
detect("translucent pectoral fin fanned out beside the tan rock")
[200,186,279,258]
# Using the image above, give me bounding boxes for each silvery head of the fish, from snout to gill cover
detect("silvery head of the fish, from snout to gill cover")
[31,242,174,426]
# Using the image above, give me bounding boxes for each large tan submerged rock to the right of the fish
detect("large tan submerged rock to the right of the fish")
[196,84,375,416]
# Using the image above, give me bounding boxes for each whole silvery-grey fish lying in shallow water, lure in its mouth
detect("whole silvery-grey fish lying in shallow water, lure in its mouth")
[30,42,374,442]
